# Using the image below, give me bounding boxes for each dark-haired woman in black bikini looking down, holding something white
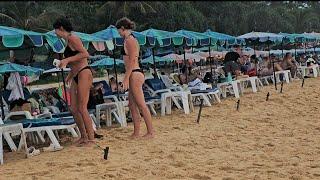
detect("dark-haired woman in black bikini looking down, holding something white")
[53,18,94,145]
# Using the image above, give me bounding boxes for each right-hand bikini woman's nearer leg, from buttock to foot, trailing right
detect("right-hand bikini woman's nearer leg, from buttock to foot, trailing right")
[130,72,154,138]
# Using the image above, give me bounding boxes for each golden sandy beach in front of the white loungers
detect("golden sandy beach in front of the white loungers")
[0,79,320,180]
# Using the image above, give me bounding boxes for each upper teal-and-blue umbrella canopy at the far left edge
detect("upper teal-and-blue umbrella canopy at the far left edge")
[0,26,43,48]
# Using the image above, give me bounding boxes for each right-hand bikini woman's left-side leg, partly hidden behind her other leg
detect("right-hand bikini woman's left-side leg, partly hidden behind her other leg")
[129,90,141,138]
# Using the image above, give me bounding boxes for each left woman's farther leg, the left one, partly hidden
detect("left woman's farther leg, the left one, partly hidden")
[70,81,88,143]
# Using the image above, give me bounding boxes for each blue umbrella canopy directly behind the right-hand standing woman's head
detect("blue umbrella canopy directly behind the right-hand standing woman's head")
[92,25,155,46]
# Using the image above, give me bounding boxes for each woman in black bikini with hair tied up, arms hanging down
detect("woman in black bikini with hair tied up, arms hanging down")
[116,18,154,138]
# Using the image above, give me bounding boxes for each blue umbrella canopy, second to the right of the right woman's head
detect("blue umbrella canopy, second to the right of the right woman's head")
[175,29,210,46]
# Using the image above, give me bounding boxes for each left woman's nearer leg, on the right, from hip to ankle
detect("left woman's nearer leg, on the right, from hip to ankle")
[77,69,94,141]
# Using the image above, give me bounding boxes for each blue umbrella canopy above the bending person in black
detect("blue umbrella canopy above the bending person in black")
[204,29,244,45]
